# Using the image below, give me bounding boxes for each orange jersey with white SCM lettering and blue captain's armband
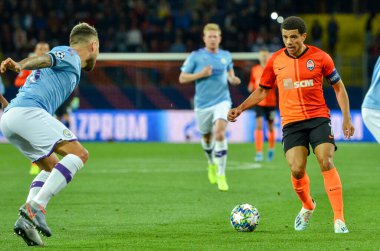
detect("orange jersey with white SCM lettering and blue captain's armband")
[260,45,340,126]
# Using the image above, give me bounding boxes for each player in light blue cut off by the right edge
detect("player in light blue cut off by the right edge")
[362,57,380,143]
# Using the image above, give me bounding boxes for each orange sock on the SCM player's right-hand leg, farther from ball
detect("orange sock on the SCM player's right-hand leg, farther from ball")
[322,168,344,222]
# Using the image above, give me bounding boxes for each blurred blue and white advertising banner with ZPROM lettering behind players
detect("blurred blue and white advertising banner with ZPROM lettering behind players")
[0,110,375,143]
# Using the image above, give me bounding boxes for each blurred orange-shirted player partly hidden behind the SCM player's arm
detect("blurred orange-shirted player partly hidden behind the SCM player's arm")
[248,49,277,162]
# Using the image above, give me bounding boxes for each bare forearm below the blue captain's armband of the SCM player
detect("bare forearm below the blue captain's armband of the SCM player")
[333,80,355,139]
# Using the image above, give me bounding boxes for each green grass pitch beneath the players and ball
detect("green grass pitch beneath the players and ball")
[0,143,380,250]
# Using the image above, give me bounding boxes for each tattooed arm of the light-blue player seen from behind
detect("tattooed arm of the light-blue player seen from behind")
[0,55,52,73]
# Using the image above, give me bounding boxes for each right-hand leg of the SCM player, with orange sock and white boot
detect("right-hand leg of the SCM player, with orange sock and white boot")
[314,143,349,233]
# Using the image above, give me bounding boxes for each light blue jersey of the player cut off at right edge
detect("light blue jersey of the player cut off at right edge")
[362,57,380,110]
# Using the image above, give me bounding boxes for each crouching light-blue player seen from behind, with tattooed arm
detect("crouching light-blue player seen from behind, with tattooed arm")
[0,23,99,245]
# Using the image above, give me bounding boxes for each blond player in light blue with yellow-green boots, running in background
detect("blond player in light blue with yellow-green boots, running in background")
[179,23,241,191]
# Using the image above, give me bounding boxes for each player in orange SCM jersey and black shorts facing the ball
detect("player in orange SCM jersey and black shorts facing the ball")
[228,16,354,233]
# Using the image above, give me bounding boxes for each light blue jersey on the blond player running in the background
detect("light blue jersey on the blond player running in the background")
[181,48,233,109]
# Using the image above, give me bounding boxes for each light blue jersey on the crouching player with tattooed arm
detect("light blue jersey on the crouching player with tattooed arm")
[5,46,81,115]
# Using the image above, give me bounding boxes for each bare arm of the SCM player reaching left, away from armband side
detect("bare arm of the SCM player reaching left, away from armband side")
[227,87,270,122]
